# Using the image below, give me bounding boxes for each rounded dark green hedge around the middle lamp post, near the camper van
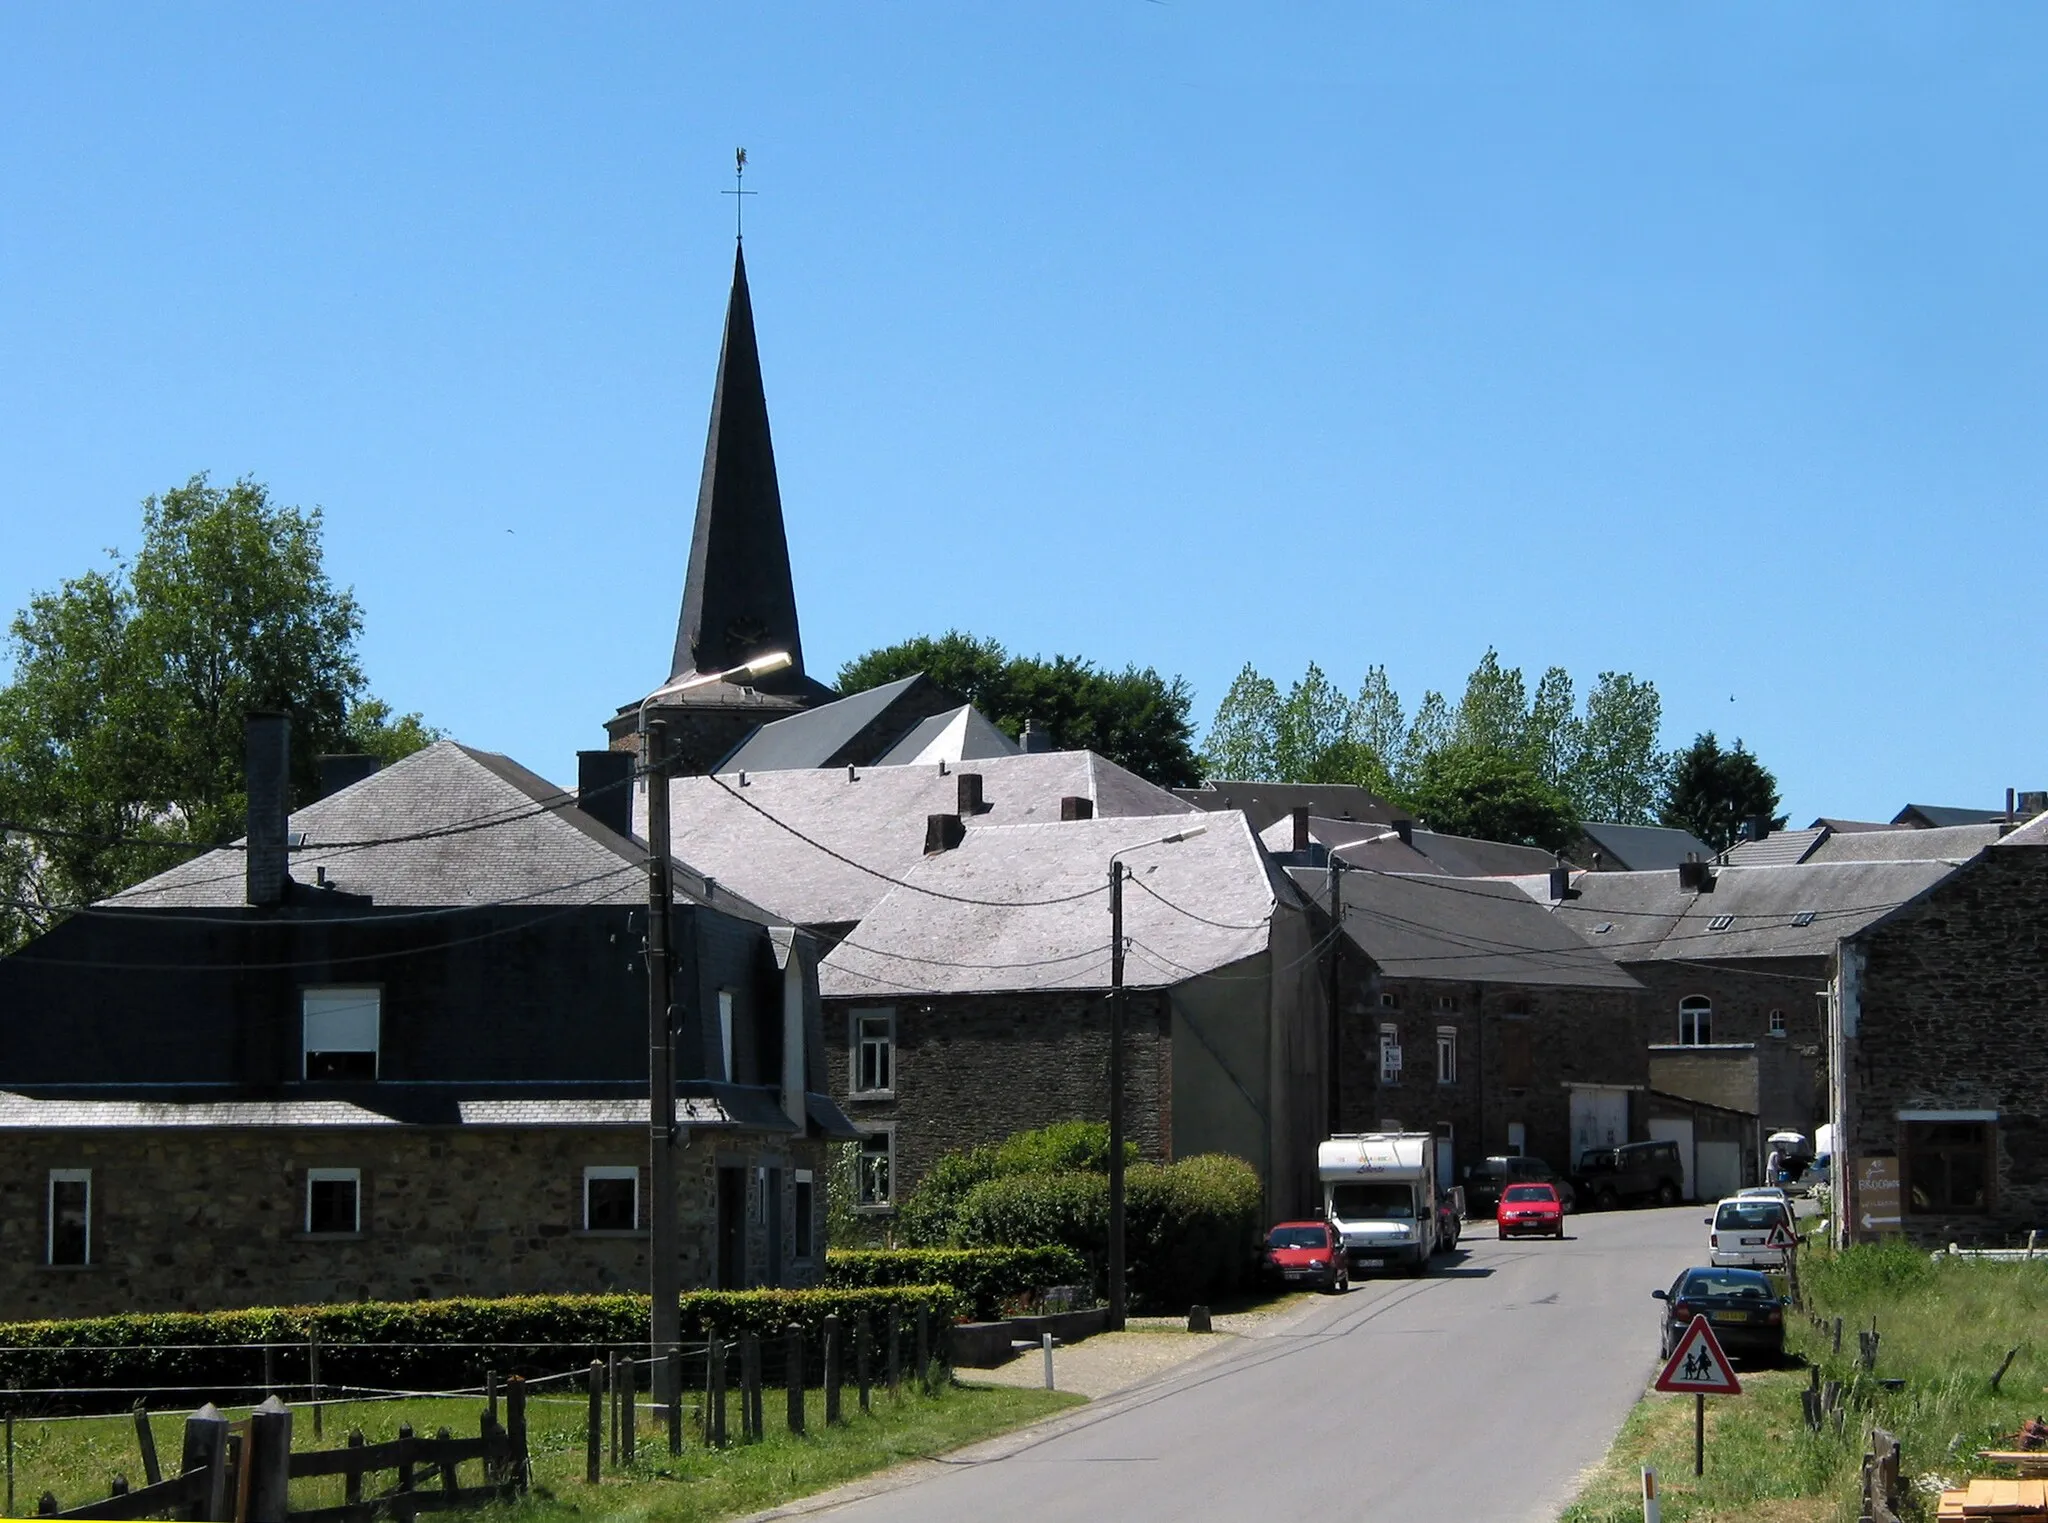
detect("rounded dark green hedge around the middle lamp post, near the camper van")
[954,1155,1260,1312]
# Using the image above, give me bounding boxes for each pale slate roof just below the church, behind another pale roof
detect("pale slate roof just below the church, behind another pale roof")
[663,751,1196,925]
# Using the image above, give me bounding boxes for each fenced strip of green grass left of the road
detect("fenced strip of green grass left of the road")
[0,1386,1081,1523]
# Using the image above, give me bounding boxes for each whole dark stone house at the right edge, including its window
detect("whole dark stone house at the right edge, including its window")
[1827,817,2048,1245]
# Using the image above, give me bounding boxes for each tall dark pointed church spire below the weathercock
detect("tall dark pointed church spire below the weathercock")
[670,250,811,692]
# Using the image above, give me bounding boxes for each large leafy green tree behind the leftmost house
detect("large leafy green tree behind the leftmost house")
[0,475,434,948]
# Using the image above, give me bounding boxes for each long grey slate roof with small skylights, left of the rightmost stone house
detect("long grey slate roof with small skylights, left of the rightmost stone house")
[1516,862,1956,962]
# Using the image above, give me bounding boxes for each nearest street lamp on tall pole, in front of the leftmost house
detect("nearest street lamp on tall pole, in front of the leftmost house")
[639,651,791,1441]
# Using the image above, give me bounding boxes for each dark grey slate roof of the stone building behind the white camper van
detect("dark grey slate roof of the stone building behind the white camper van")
[1292,868,1638,989]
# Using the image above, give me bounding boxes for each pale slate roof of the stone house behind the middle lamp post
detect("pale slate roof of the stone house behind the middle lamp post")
[819,811,1292,999]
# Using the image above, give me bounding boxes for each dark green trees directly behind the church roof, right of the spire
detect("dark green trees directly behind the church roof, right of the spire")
[840,630,1200,788]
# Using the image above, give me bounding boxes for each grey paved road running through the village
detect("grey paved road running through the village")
[811,1206,1706,1523]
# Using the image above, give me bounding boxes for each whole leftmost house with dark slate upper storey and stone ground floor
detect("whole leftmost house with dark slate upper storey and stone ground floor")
[0,716,848,1318]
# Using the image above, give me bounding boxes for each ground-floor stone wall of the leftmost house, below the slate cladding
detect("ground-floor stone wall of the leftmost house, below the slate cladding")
[0,1128,825,1318]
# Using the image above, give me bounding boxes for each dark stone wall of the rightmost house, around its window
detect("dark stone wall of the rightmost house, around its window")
[1843,845,2048,1243]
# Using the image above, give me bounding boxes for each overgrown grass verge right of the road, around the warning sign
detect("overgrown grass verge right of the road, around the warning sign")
[1565,1243,2048,1523]
